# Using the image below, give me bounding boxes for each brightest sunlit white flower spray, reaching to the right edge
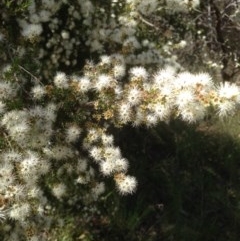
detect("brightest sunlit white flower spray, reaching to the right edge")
[79,55,239,126]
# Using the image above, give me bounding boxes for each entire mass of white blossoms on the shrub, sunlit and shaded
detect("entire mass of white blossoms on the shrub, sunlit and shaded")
[0,0,240,241]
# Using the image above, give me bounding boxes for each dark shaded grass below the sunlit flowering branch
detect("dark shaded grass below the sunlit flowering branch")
[100,123,240,241]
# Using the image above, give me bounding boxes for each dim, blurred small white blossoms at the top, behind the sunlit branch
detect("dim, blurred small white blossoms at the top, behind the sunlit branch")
[8,0,184,78]
